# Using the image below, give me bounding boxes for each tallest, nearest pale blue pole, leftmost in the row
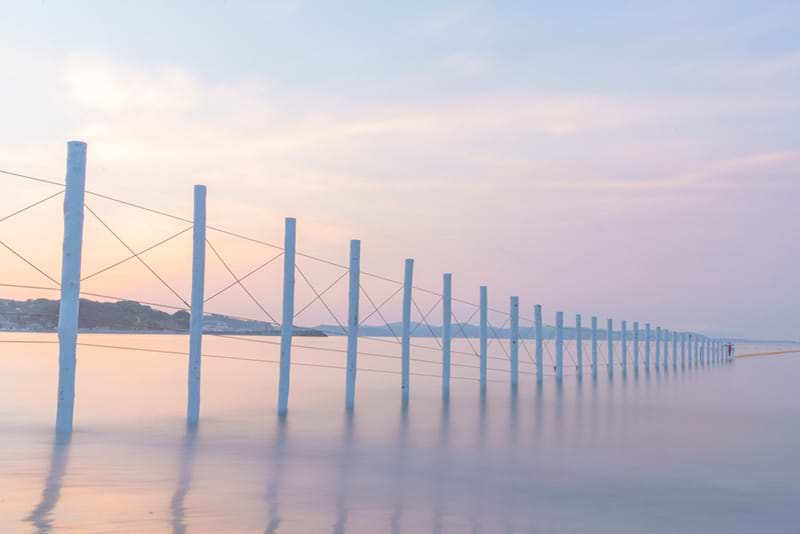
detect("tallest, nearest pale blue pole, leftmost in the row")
[56,141,86,433]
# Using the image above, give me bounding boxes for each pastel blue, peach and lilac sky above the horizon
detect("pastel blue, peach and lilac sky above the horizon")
[0,0,800,339]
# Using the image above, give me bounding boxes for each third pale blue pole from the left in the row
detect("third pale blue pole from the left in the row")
[278,217,297,417]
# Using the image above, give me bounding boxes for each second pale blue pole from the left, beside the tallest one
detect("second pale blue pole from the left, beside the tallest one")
[186,185,206,428]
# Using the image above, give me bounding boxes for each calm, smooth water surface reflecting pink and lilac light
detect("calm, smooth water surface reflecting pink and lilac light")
[0,334,800,533]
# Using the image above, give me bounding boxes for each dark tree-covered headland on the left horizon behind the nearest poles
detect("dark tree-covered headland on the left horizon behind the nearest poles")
[0,299,325,336]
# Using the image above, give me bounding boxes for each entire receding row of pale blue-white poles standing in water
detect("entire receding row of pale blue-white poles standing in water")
[51,141,733,432]
